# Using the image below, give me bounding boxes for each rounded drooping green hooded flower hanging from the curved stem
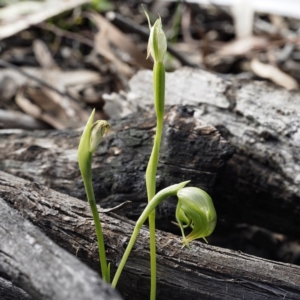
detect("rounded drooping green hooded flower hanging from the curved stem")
[176,187,217,246]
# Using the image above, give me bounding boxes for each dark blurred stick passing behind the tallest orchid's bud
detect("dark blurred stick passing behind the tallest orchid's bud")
[106,12,203,69]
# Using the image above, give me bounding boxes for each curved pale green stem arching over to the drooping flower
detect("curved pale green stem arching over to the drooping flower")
[111,181,189,288]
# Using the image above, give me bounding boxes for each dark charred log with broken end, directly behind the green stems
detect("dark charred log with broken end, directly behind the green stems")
[0,107,233,227]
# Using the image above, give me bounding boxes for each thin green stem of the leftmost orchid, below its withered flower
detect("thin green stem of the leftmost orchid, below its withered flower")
[83,153,110,283]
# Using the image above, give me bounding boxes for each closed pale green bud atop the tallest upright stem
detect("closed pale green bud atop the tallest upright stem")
[143,7,167,62]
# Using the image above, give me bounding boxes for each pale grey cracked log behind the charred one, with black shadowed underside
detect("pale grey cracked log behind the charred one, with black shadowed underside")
[113,68,300,238]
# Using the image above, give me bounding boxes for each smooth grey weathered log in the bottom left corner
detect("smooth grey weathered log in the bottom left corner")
[0,196,121,300]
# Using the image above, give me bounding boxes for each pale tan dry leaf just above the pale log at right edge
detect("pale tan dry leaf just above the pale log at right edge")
[251,58,299,90]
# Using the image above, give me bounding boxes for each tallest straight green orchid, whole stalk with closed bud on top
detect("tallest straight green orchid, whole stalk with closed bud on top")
[145,11,167,300]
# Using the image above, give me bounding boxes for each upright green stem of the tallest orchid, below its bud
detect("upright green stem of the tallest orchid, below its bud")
[146,62,165,300]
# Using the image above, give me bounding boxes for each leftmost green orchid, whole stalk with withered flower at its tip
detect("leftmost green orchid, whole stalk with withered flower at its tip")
[78,110,110,283]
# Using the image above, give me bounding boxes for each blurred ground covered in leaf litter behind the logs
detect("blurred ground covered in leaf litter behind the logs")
[0,0,300,264]
